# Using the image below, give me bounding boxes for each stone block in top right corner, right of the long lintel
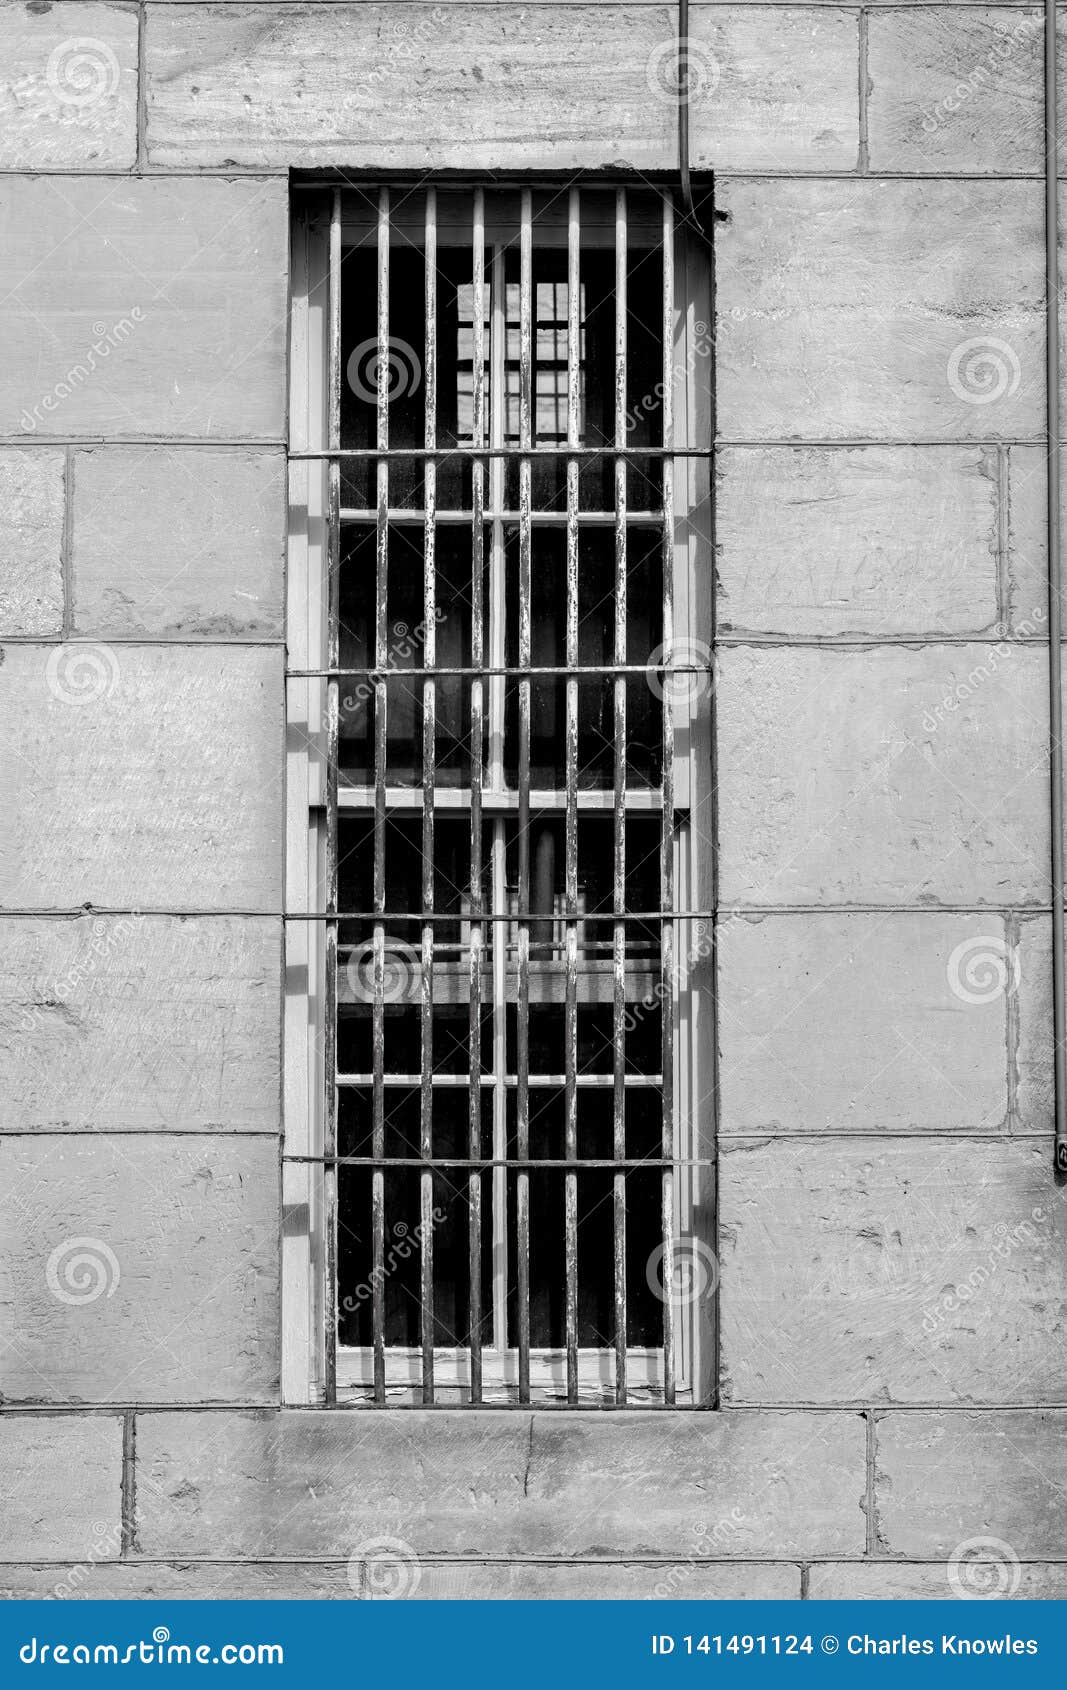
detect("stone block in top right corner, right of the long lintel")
[867,5,1045,176]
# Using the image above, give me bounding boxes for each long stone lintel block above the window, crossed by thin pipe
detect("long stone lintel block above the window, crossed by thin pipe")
[147,3,859,169]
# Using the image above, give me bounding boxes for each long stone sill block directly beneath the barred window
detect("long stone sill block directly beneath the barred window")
[137,1411,864,1560]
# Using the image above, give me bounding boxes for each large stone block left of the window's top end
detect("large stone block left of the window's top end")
[0,176,289,439]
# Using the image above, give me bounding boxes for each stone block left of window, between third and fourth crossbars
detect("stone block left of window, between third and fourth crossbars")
[0,916,281,1132]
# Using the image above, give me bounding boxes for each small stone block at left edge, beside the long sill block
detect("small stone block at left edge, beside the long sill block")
[0,1415,122,1554]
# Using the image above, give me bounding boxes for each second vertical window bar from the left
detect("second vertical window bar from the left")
[370,188,389,1403]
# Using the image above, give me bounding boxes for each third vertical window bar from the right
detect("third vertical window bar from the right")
[563,188,582,1403]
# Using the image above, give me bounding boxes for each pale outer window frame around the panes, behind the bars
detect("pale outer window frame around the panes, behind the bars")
[282,176,715,1406]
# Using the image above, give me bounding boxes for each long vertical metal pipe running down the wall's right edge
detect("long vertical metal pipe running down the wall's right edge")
[1045,0,1067,1175]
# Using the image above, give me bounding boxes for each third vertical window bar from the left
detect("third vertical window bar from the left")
[419,188,438,1403]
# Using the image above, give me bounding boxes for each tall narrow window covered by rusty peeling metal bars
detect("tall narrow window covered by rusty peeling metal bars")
[284,179,715,1406]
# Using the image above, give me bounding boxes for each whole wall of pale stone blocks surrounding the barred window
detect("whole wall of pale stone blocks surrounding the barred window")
[0,0,1067,1597]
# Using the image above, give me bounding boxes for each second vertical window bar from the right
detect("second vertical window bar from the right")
[612,188,627,1403]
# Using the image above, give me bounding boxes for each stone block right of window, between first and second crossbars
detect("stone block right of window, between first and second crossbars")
[715,446,999,637]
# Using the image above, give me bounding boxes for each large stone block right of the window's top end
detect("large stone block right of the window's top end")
[715,181,1045,441]
